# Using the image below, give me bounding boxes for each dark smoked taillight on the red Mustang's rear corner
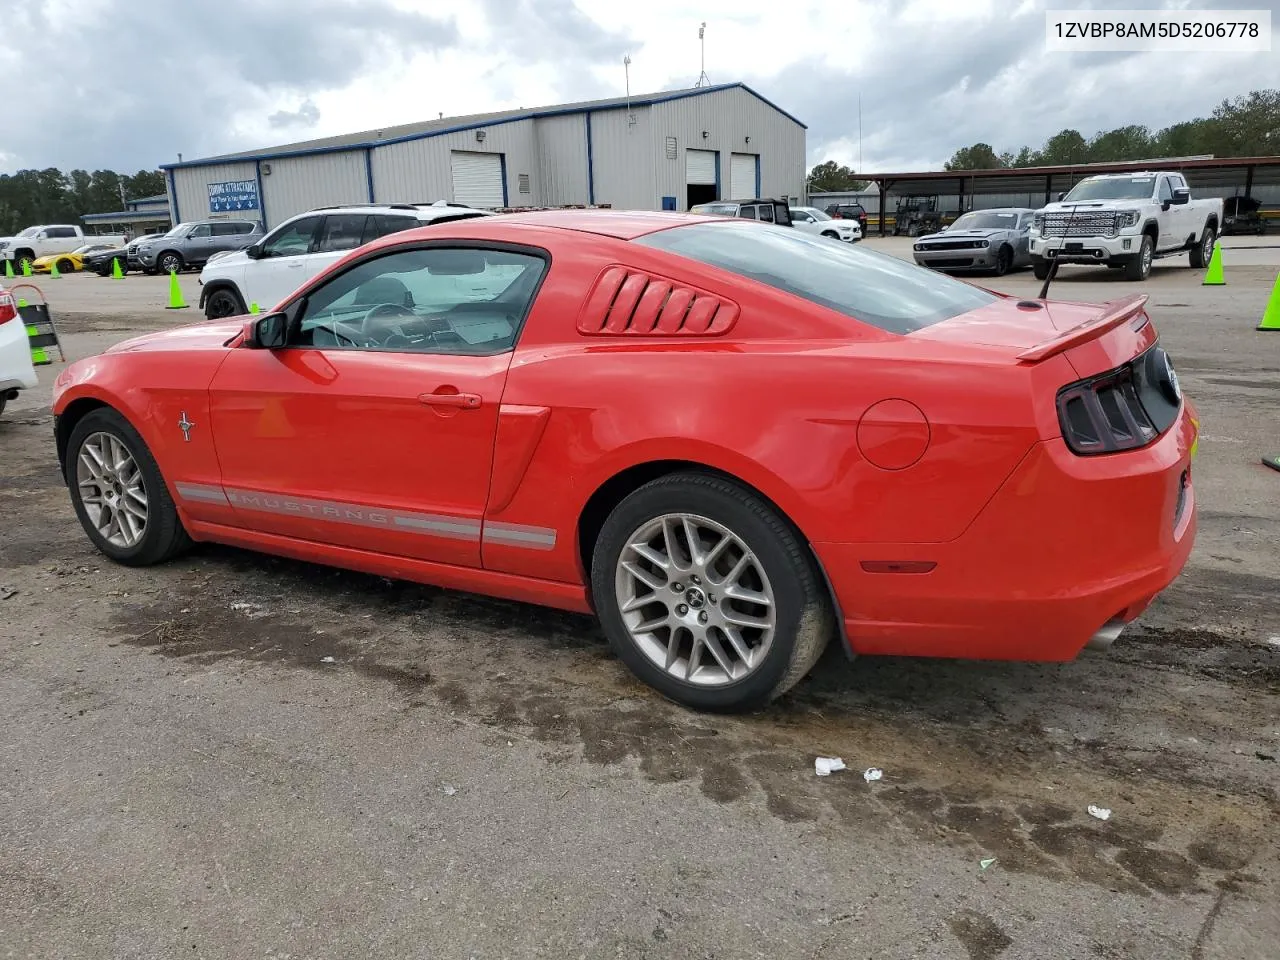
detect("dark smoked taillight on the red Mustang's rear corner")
[1057,347,1180,456]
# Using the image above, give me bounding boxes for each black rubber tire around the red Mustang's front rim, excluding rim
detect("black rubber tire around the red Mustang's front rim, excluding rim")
[65,407,191,567]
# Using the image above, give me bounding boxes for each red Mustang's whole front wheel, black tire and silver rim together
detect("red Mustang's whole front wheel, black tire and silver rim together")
[67,408,191,567]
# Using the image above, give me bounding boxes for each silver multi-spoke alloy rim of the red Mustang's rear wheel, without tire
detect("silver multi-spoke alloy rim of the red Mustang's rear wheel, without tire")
[614,513,777,686]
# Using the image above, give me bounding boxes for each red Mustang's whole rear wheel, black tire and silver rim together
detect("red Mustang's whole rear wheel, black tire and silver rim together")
[591,474,833,710]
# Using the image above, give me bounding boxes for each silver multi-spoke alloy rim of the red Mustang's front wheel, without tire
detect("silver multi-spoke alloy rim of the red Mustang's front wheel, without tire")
[76,433,147,549]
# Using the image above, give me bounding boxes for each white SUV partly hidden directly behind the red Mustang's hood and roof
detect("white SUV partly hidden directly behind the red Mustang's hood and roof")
[200,200,493,320]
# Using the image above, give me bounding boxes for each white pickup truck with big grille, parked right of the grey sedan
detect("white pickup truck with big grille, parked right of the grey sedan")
[1030,172,1222,280]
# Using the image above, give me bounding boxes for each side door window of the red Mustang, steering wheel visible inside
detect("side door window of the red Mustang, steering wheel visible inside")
[291,247,547,356]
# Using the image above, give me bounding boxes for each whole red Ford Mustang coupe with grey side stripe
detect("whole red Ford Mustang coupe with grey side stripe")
[54,211,1197,709]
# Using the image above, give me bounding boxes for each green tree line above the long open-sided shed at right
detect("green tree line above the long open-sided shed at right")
[946,90,1280,170]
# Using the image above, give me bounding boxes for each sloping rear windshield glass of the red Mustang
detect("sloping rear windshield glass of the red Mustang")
[635,220,997,334]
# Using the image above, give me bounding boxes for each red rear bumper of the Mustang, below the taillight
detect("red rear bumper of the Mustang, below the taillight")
[814,407,1196,660]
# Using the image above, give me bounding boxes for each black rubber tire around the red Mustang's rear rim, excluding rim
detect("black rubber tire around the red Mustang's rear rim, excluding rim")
[591,472,835,712]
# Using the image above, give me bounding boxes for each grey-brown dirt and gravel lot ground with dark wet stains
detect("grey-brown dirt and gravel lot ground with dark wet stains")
[0,249,1280,960]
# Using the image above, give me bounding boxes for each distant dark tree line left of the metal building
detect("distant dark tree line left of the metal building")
[0,166,165,237]
